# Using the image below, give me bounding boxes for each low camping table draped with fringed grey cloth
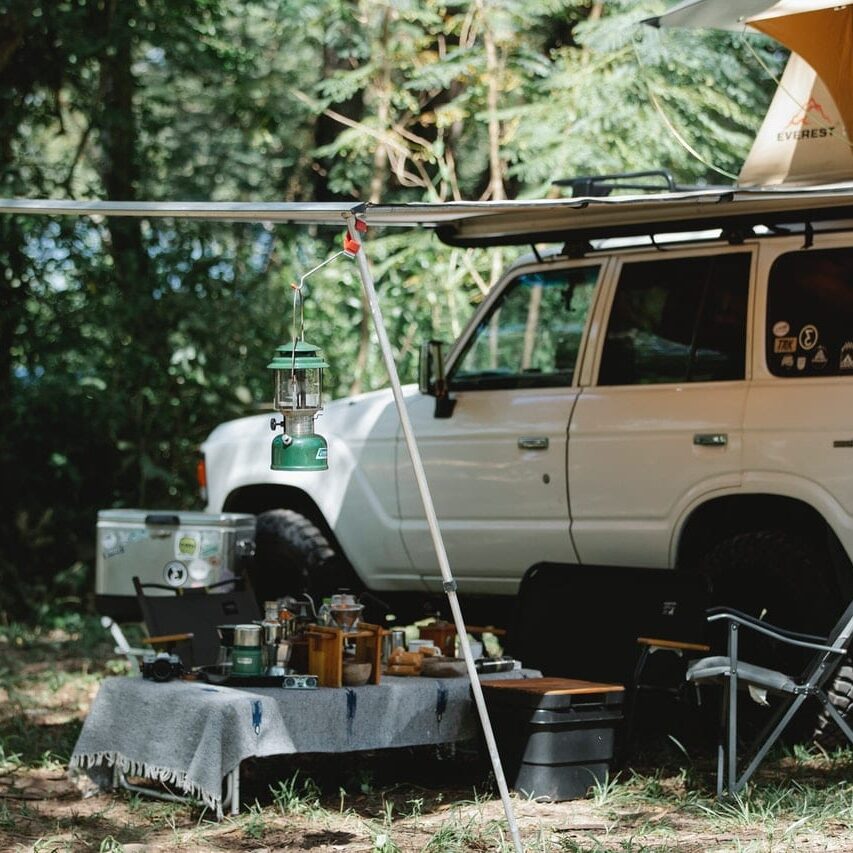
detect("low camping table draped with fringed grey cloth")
[70,670,540,816]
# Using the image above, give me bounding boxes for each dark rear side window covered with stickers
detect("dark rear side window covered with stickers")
[766,248,853,376]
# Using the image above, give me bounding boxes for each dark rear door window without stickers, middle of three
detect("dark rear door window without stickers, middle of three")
[598,253,750,385]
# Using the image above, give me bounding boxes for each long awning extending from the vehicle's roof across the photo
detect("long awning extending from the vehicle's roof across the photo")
[0,183,853,247]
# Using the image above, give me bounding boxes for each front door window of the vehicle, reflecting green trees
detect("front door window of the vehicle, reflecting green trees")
[449,265,600,390]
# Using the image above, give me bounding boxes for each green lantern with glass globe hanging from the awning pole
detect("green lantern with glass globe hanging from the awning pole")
[267,340,329,471]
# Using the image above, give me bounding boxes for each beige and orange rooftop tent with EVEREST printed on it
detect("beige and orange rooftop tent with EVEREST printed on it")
[646,0,853,184]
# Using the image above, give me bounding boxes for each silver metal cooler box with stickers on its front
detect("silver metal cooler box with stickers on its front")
[95,509,255,619]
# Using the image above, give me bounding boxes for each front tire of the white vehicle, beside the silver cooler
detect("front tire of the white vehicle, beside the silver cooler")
[250,509,347,606]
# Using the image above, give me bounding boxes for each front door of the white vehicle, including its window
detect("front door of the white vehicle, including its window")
[397,262,601,593]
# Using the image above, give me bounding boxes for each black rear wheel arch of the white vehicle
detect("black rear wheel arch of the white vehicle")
[675,493,853,599]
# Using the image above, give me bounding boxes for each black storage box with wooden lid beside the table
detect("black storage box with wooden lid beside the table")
[483,678,624,801]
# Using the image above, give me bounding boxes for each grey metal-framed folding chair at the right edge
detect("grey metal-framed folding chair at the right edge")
[687,603,853,797]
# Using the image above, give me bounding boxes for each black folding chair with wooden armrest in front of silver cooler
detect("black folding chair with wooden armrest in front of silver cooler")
[133,577,261,668]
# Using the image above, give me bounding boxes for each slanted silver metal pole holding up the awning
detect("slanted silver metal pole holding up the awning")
[344,212,524,853]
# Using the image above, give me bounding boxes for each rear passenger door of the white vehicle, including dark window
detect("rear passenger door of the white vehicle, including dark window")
[568,246,753,568]
